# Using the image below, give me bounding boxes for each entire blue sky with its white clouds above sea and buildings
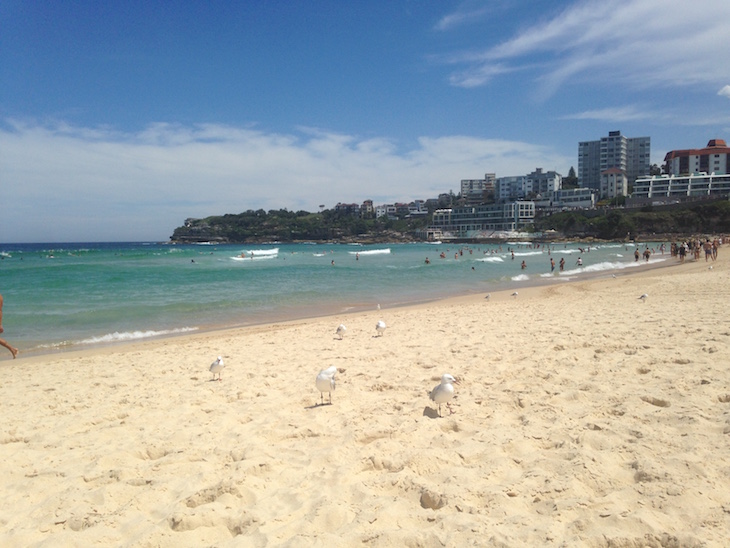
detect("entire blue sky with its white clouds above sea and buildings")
[0,0,730,242]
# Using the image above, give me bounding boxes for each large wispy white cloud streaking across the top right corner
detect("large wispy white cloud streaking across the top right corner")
[440,0,730,96]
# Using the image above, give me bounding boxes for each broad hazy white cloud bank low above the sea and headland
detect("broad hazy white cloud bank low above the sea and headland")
[0,121,570,242]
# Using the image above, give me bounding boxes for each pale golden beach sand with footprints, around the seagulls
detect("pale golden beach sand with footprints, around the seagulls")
[0,247,730,547]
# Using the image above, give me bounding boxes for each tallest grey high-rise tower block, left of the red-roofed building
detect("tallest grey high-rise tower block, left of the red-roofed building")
[578,131,651,192]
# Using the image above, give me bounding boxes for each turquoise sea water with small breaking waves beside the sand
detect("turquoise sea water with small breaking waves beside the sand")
[0,242,670,359]
